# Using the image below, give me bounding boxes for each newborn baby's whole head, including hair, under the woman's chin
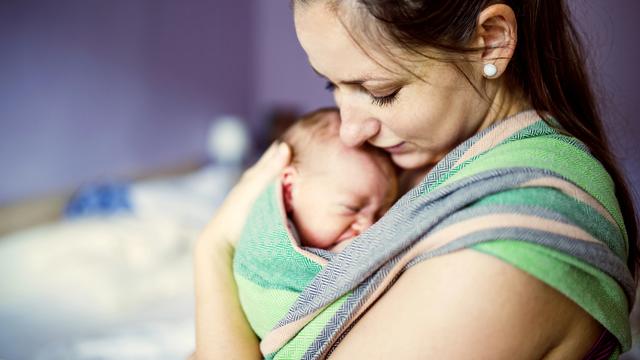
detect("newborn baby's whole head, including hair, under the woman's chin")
[282,109,397,249]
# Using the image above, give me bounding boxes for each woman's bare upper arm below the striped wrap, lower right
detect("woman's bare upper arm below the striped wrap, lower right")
[330,250,602,360]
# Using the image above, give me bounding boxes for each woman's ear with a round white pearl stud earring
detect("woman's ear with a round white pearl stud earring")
[474,4,518,79]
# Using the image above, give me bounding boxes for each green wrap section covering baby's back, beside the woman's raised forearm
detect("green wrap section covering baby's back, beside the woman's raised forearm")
[233,182,321,338]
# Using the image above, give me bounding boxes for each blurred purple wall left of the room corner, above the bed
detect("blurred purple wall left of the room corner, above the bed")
[0,0,254,204]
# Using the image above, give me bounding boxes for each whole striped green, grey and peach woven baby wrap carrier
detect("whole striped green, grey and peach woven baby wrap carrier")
[234,111,635,359]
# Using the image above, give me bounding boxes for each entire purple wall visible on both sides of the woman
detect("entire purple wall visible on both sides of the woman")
[0,0,640,205]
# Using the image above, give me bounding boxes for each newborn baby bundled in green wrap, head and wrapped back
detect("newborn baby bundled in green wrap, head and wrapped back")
[234,109,397,338]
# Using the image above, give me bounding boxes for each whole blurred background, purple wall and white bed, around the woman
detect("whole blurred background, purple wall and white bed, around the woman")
[0,0,640,359]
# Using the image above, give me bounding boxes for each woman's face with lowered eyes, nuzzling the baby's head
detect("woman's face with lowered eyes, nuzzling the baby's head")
[295,1,500,169]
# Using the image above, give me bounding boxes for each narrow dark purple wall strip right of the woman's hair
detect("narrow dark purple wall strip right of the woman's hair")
[570,0,640,194]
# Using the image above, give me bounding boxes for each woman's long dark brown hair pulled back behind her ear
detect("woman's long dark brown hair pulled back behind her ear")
[294,0,638,277]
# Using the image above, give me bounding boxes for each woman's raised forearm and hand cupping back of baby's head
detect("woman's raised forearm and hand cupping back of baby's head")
[193,144,290,360]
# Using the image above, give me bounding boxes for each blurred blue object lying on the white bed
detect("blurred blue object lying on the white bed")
[64,183,132,218]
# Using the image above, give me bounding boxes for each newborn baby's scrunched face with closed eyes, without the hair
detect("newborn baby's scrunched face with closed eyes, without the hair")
[290,147,397,249]
